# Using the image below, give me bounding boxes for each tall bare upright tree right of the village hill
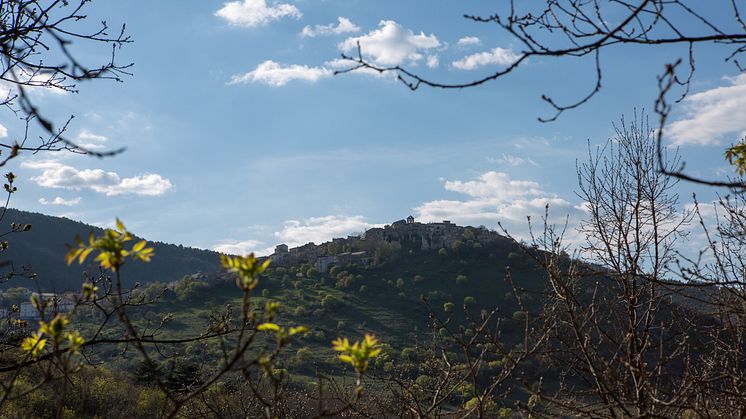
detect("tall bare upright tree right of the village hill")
[516,116,696,417]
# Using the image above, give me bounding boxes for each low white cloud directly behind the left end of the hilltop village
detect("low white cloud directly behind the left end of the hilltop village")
[275,215,380,247]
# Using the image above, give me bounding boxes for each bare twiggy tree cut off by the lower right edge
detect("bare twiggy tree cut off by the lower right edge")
[678,193,746,416]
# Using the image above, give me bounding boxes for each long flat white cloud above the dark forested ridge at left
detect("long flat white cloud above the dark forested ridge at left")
[21,160,173,196]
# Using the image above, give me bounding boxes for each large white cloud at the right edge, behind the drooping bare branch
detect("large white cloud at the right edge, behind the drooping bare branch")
[665,74,746,145]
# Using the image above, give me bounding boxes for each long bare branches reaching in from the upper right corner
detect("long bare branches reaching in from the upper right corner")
[335,0,746,188]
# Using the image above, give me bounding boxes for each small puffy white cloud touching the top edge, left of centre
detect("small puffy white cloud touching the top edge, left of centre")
[215,0,303,28]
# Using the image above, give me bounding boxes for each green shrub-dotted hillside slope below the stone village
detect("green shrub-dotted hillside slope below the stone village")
[91,233,545,388]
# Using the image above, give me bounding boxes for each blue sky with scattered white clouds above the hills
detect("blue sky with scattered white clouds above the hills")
[0,0,746,254]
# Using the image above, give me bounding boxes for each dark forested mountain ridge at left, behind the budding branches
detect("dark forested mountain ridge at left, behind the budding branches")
[0,209,219,291]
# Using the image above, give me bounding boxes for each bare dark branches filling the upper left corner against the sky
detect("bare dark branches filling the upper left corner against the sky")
[0,0,132,166]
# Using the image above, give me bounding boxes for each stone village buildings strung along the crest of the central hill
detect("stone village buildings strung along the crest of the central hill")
[269,215,502,272]
